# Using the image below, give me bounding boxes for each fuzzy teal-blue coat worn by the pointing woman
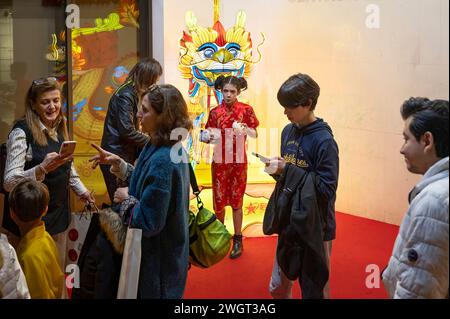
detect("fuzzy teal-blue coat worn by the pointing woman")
[129,144,190,299]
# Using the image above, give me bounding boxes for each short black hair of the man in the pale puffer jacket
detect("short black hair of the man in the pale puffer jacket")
[401,98,449,158]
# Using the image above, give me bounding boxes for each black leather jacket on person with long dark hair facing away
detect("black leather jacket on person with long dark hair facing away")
[101,81,149,165]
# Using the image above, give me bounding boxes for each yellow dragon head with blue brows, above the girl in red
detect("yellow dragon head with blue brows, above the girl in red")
[179,11,264,108]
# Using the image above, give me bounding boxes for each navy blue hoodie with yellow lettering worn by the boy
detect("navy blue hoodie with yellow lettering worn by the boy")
[281,119,339,241]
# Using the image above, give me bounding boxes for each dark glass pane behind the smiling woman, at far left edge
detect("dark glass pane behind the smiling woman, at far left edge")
[0,0,65,226]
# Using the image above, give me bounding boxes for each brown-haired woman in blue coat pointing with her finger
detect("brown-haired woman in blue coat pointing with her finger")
[91,85,192,299]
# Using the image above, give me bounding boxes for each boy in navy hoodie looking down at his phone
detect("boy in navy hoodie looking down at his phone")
[266,73,339,298]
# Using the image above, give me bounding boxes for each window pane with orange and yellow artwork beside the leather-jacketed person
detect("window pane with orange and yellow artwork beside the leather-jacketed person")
[71,0,139,209]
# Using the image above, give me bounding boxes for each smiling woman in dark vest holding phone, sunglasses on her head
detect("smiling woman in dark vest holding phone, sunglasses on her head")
[3,77,94,252]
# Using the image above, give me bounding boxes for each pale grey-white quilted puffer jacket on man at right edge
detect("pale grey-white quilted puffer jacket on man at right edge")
[383,157,449,299]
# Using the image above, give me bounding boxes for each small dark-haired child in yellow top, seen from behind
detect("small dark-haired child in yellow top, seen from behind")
[9,179,64,299]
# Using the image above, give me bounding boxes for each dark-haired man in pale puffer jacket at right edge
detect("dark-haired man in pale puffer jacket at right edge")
[382,98,449,299]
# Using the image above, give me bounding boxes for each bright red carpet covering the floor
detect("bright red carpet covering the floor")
[185,213,398,299]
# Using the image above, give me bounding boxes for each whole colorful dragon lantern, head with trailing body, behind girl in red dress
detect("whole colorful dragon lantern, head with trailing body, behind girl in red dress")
[178,0,265,169]
